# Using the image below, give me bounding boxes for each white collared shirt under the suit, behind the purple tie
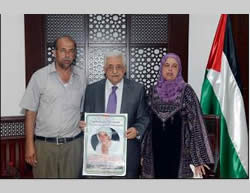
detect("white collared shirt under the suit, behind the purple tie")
[105,79,124,113]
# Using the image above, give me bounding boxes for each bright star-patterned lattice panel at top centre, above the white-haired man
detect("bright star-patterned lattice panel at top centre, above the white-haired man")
[89,14,127,43]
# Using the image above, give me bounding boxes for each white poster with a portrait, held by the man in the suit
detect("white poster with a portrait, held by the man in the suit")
[82,113,127,176]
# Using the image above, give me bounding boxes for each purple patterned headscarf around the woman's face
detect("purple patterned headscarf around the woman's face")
[156,53,186,102]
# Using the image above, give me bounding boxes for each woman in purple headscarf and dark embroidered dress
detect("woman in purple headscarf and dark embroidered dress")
[142,53,214,179]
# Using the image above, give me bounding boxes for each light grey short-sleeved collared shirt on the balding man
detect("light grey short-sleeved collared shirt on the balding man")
[20,63,87,137]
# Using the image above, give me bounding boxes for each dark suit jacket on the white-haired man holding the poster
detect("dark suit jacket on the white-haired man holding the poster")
[82,78,150,178]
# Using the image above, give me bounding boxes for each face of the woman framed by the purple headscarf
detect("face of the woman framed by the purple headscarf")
[162,57,179,80]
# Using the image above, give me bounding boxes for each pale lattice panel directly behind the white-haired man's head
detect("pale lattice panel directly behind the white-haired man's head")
[87,47,126,83]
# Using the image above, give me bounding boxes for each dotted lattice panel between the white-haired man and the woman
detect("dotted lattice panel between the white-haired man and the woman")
[129,47,167,92]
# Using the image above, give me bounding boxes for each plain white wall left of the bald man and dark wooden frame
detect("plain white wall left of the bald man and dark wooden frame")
[1,13,25,116]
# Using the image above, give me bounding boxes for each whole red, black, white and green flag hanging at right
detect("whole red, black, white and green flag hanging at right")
[201,14,248,178]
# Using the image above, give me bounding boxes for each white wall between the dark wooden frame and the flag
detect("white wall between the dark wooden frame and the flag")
[188,14,220,99]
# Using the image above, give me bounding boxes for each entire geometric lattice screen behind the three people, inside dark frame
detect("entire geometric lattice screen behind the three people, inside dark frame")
[46,14,168,92]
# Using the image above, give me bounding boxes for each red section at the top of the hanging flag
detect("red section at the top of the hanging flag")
[207,14,227,72]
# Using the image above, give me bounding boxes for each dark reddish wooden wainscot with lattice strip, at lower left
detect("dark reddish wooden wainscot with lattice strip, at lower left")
[0,116,33,178]
